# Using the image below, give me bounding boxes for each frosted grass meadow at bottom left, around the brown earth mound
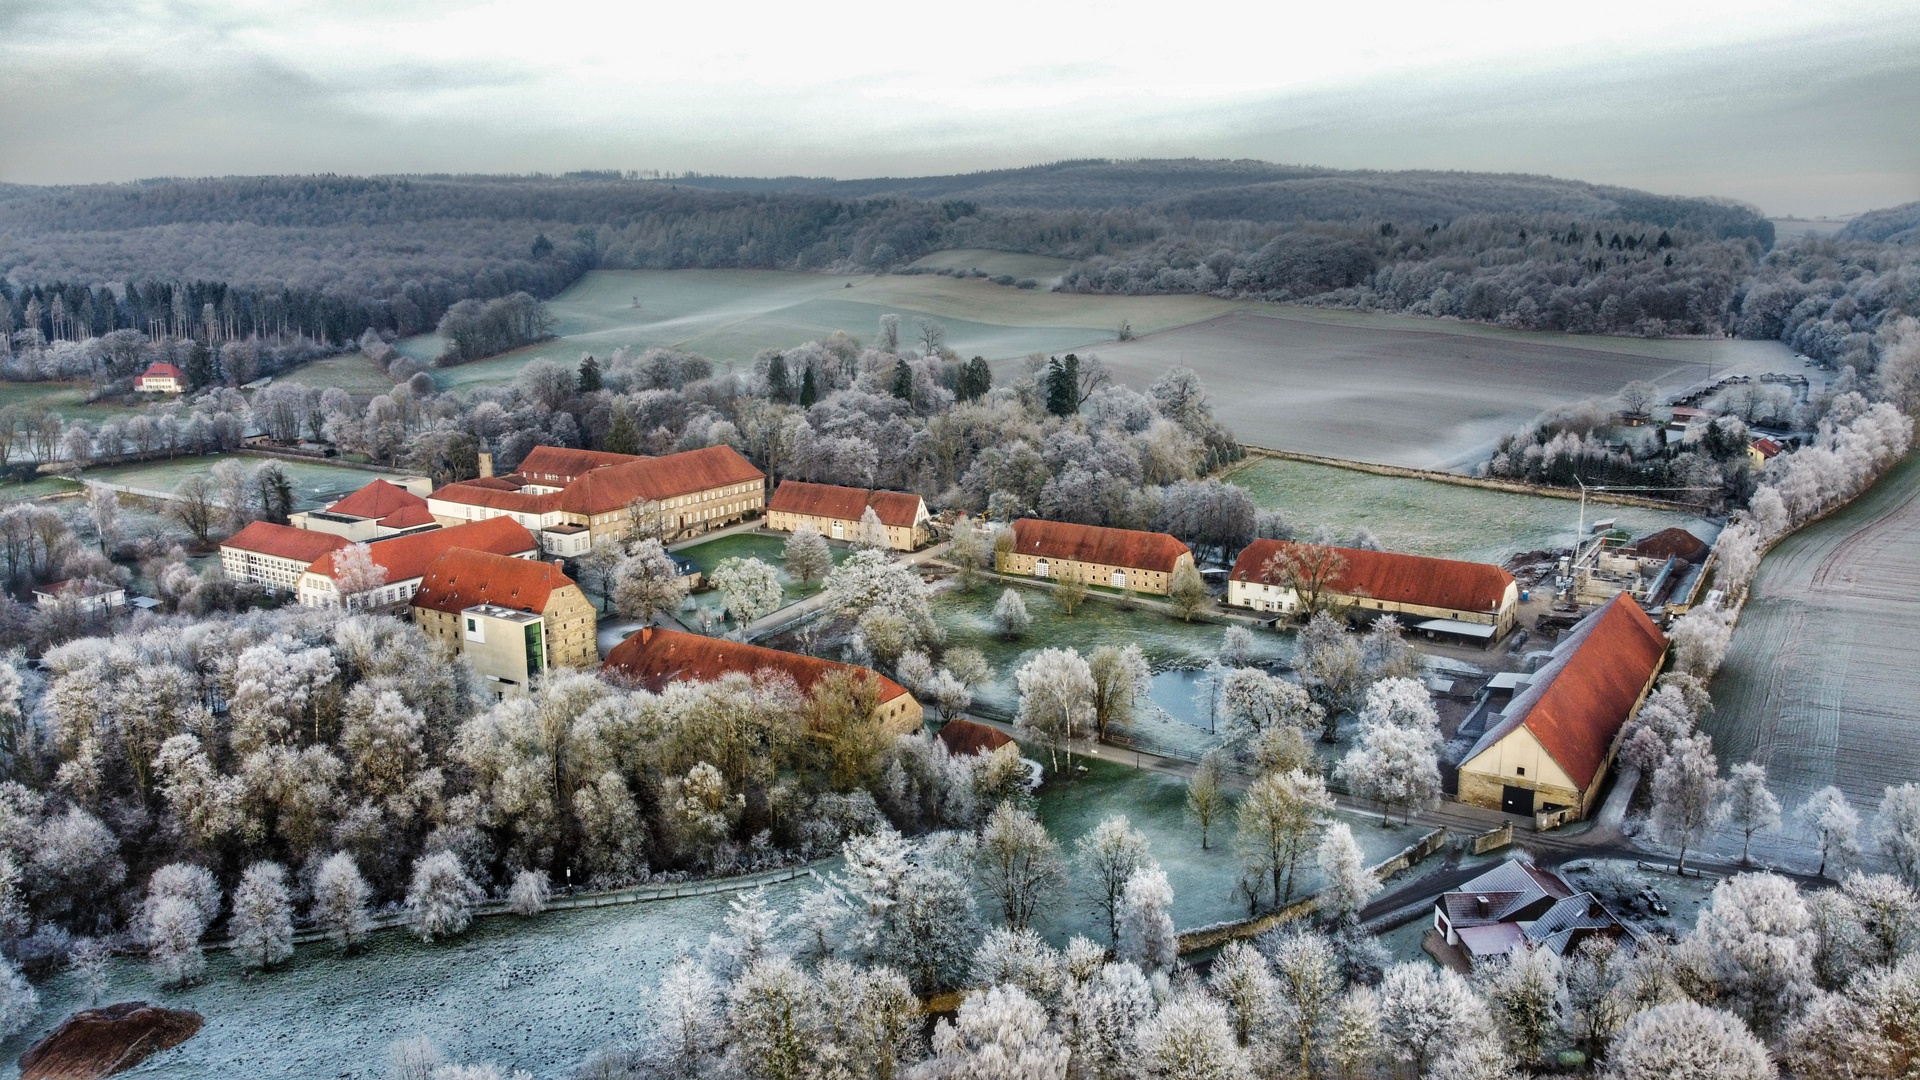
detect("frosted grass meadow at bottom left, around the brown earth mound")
[0,878,804,1080]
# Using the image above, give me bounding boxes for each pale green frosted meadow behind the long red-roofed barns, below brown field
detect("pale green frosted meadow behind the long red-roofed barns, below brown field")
[1231,457,1720,563]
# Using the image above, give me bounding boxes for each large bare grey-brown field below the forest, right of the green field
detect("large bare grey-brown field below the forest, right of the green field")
[1098,306,1803,469]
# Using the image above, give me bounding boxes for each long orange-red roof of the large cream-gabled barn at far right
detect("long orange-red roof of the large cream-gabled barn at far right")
[1461,592,1667,790]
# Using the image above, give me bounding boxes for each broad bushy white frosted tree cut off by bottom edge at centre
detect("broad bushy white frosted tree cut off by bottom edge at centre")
[914,986,1069,1080]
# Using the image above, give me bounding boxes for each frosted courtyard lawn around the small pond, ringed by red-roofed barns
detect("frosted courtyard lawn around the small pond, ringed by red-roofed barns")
[933,580,1292,728]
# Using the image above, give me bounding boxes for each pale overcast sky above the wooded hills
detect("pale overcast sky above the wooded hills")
[0,0,1920,215]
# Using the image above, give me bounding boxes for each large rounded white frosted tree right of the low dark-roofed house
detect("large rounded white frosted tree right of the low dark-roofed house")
[1676,874,1814,1034]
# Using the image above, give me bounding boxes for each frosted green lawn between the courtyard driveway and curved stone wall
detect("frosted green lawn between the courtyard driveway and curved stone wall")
[1029,748,1421,944]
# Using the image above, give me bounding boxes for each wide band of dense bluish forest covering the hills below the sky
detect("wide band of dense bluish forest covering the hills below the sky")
[0,161,1920,367]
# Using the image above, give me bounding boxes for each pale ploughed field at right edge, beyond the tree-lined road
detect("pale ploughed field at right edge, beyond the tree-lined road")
[1701,455,1920,807]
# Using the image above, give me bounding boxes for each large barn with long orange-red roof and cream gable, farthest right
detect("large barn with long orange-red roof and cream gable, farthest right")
[1459,596,1667,821]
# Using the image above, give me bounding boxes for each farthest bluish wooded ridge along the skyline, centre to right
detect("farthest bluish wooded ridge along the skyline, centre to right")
[656,160,1774,244]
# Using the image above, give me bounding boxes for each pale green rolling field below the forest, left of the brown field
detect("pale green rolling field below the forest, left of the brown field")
[399,265,1244,388]
